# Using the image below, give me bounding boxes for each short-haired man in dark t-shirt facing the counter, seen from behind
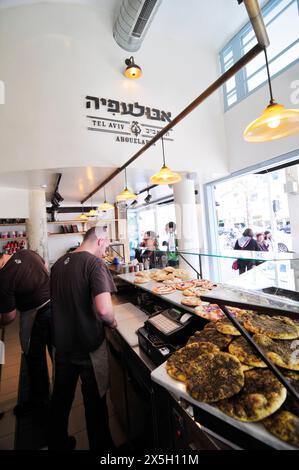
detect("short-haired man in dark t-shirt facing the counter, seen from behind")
[49,227,116,452]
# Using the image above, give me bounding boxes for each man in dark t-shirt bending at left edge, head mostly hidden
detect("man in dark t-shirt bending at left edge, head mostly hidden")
[0,250,52,416]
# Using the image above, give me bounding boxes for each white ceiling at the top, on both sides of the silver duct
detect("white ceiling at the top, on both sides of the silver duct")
[0,0,267,52]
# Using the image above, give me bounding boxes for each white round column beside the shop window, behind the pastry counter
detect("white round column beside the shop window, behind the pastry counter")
[173,177,199,277]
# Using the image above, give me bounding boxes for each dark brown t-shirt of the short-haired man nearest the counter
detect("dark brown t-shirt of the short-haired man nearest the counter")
[51,251,116,353]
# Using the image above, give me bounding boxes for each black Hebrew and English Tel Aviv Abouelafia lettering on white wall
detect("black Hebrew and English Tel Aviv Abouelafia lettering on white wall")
[85,96,173,145]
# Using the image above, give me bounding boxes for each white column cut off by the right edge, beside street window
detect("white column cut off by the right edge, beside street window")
[285,165,299,253]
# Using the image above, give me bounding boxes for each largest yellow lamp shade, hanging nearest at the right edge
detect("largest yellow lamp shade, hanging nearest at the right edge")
[243,103,299,142]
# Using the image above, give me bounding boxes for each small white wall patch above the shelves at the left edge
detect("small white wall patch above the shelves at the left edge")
[0,188,29,219]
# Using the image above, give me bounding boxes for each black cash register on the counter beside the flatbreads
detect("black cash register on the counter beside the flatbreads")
[137,308,202,365]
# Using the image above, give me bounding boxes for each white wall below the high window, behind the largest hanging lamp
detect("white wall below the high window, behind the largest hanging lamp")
[224,63,299,172]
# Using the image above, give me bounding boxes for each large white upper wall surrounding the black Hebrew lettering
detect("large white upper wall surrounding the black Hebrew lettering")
[0,2,227,181]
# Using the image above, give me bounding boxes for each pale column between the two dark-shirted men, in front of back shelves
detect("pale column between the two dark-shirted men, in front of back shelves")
[26,189,49,264]
